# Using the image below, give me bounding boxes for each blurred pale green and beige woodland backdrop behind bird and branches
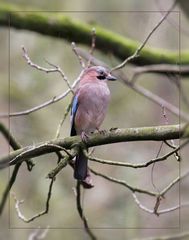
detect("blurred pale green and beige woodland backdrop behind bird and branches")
[0,0,189,240]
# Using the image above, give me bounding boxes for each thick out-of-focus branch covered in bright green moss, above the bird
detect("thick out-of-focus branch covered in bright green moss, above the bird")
[0,3,189,65]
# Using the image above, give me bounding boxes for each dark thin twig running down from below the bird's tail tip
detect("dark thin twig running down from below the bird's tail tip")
[76,181,97,240]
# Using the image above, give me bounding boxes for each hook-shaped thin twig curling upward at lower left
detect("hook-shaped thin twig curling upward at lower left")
[13,178,55,223]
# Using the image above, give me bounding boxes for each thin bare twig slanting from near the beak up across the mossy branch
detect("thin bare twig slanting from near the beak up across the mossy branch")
[111,0,176,72]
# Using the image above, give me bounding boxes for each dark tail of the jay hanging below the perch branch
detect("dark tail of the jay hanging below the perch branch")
[74,151,88,181]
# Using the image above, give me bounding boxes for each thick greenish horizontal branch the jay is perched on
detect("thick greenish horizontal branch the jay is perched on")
[0,125,189,168]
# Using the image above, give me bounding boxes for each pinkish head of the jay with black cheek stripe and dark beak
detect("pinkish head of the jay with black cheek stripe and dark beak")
[82,66,116,84]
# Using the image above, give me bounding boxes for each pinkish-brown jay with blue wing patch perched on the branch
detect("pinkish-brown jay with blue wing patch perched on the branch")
[70,66,116,188]
